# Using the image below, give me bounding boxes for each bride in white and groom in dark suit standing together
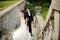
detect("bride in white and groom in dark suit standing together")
[13,8,33,40]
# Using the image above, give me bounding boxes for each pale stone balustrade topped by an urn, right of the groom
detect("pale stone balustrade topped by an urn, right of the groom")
[34,6,44,40]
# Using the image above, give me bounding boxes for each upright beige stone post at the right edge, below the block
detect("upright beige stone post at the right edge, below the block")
[54,11,60,40]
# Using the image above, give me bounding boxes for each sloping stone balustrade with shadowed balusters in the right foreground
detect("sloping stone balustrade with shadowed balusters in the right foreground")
[38,1,54,40]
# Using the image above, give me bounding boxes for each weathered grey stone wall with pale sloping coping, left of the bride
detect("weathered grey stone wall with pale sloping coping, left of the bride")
[0,0,25,30]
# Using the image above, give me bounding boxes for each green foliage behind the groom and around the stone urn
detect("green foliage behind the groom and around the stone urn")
[26,2,50,20]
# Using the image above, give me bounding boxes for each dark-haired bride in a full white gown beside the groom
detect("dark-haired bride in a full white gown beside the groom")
[13,13,32,40]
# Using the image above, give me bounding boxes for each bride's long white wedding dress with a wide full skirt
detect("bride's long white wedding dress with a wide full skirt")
[13,19,32,40]
